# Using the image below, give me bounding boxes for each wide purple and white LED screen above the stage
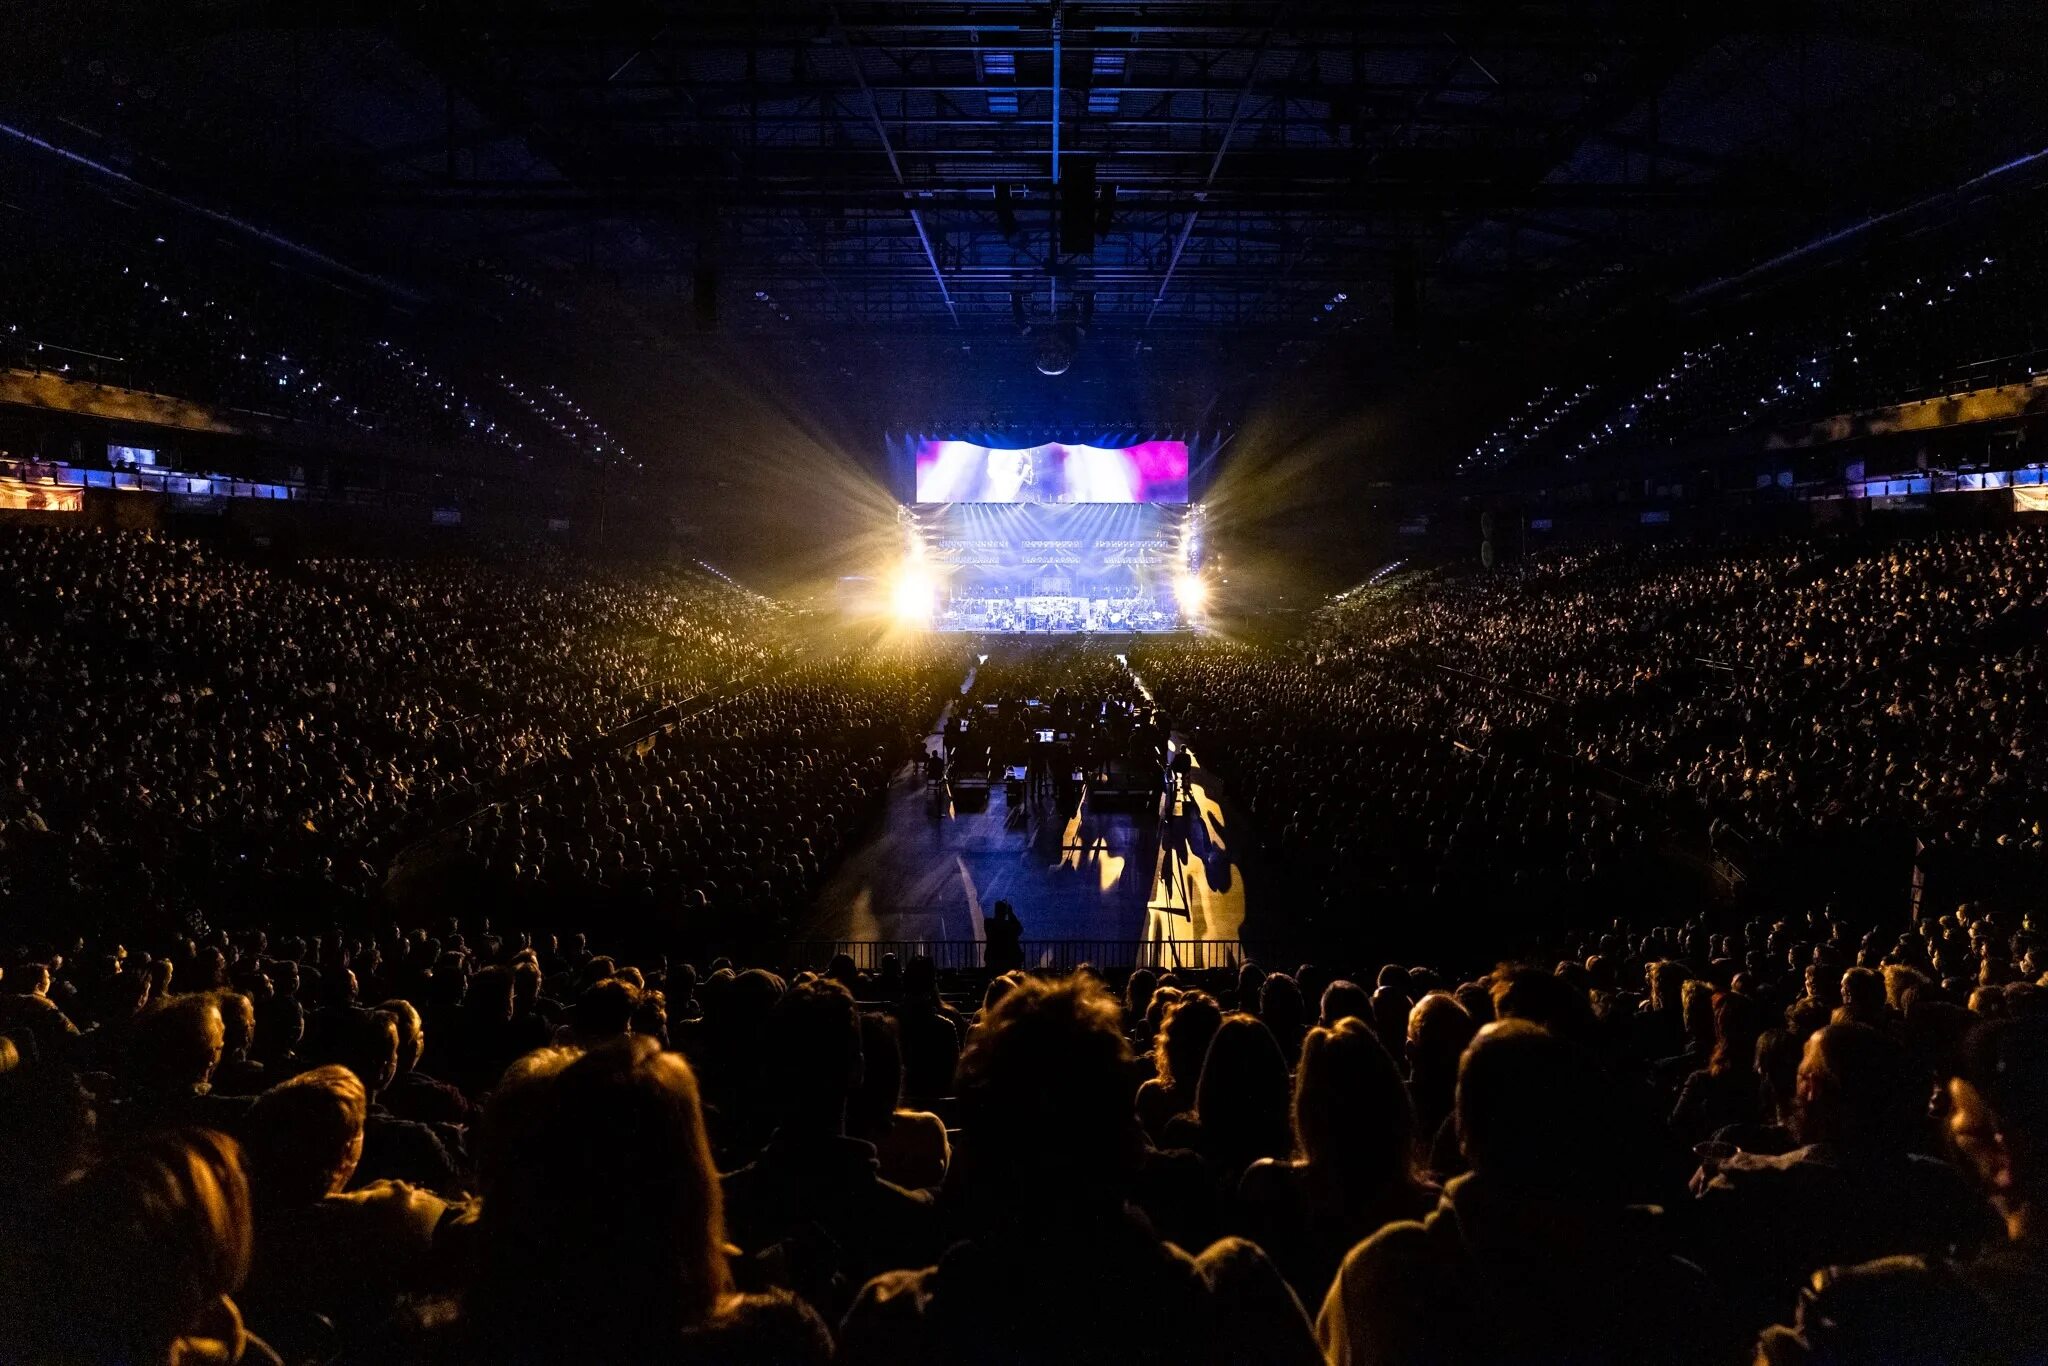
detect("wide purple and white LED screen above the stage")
[918,440,1188,502]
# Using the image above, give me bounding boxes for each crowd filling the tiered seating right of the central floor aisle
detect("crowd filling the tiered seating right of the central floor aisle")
[1130,528,2048,933]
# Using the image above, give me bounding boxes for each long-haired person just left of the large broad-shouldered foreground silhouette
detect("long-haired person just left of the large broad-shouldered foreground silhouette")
[1239,1023,1433,1305]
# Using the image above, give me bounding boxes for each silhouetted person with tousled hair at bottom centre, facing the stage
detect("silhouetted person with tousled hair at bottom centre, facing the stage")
[840,977,1317,1366]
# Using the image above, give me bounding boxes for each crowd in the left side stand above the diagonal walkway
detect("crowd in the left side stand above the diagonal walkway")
[0,528,788,922]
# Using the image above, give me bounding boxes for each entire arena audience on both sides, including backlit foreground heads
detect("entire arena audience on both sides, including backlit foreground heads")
[0,511,2048,1364]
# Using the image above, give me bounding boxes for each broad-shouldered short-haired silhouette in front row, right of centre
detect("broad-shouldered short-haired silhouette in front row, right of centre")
[1317,1020,1729,1366]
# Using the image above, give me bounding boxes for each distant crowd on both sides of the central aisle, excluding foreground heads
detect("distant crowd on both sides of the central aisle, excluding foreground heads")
[0,518,2048,948]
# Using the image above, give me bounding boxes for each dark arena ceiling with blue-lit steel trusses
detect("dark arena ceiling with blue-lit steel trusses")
[0,0,2048,432]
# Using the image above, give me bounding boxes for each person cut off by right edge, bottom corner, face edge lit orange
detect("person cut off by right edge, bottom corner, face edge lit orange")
[1757,1018,2048,1366]
